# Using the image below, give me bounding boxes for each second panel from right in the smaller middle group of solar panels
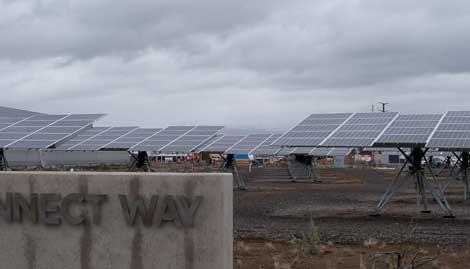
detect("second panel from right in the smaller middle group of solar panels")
[130,126,195,152]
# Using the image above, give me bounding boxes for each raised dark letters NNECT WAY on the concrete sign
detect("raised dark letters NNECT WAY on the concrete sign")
[0,192,203,228]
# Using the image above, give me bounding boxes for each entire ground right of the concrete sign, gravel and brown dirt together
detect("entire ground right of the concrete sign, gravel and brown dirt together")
[234,165,470,269]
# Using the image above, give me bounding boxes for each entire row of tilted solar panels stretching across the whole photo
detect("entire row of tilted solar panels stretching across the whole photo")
[6,111,470,153]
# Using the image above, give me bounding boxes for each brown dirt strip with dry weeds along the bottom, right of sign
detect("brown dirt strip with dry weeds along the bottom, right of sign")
[234,239,470,269]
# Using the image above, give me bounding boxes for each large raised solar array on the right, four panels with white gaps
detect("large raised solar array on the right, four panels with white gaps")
[273,111,470,150]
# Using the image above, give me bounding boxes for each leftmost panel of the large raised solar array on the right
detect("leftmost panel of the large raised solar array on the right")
[273,113,352,147]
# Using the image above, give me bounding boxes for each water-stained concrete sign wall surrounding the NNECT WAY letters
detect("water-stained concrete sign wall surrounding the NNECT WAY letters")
[0,172,233,269]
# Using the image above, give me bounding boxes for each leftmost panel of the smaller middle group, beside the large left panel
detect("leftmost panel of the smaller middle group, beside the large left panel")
[57,127,137,150]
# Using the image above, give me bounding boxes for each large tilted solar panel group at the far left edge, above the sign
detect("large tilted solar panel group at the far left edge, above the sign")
[0,114,103,149]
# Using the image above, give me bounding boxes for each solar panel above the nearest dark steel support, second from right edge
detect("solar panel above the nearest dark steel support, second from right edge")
[374,114,443,147]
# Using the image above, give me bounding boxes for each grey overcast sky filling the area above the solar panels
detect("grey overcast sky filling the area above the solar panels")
[0,0,470,130]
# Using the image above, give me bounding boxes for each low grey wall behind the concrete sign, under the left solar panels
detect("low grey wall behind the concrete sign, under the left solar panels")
[5,150,130,167]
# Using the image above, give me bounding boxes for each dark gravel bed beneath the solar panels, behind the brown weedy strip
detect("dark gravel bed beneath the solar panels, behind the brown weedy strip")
[234,169,470,245]
